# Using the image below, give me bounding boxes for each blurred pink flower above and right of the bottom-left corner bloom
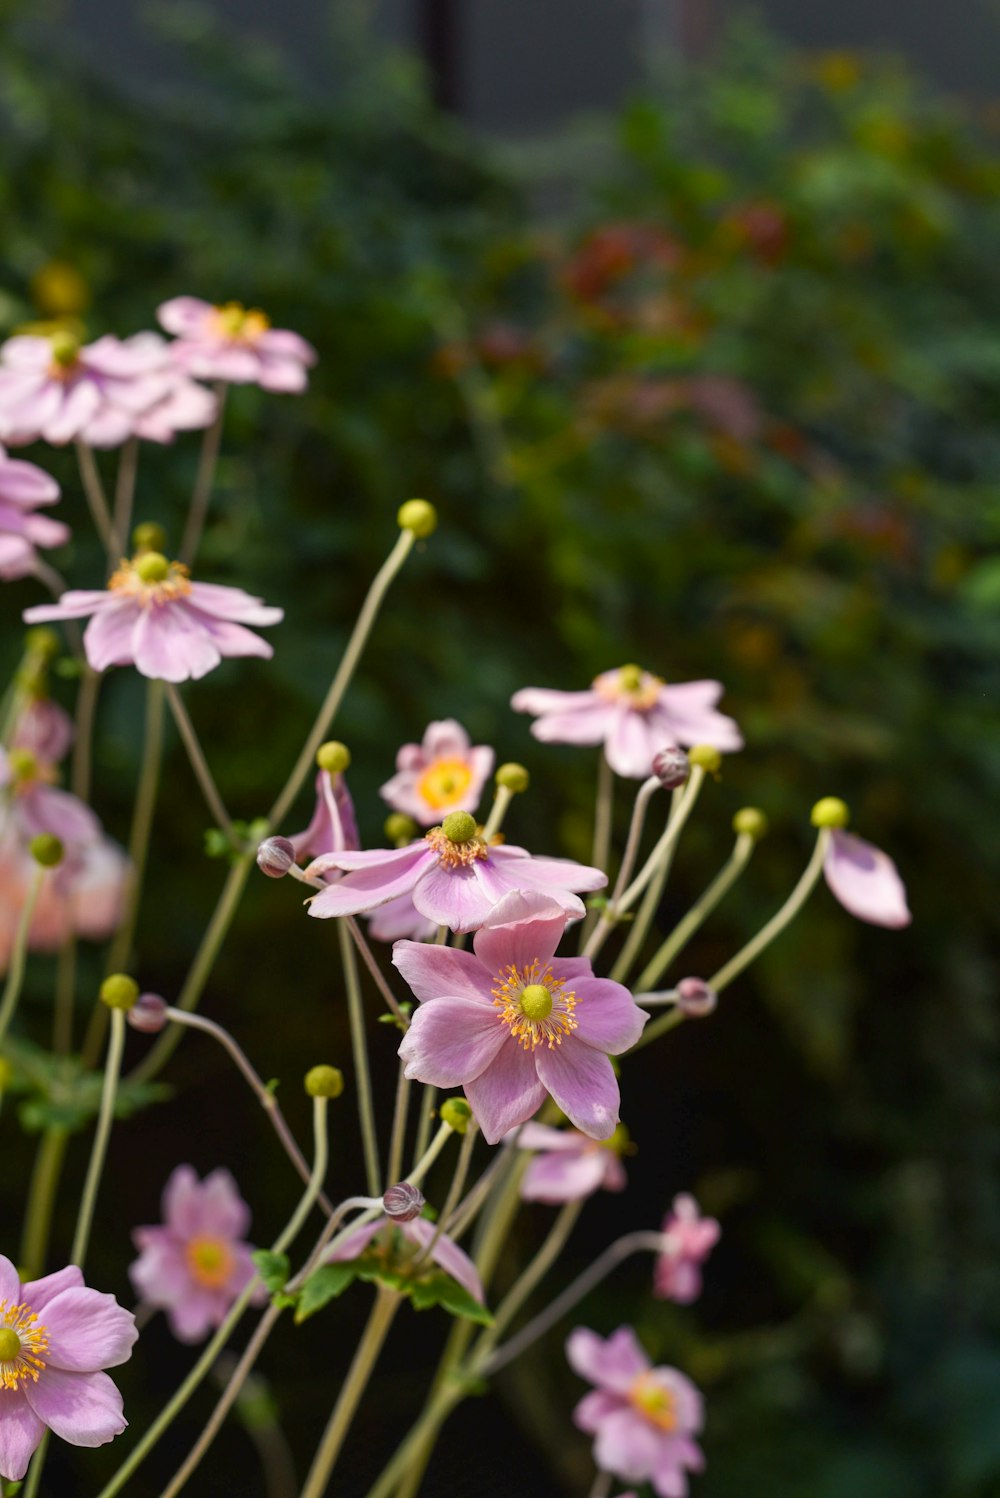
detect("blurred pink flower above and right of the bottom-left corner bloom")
[129,1165,266,1342]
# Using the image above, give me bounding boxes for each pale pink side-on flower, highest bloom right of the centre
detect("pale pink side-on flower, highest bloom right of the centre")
[510,665,743,780]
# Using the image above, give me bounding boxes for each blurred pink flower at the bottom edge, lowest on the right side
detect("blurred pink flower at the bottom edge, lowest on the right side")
[566,1326,705,1498]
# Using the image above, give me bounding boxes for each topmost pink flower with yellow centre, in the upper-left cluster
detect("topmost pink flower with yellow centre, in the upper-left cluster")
[157,297,316,392]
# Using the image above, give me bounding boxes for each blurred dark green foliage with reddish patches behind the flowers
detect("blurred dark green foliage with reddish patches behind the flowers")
[0,7,1000,1498]
